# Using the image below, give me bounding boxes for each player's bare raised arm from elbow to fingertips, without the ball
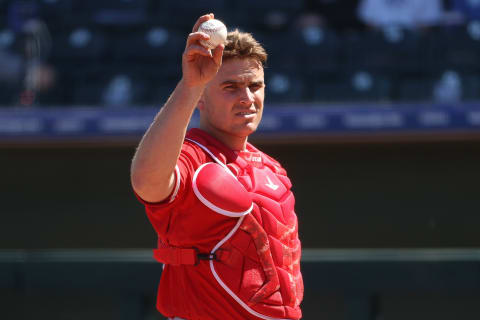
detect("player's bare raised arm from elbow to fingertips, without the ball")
[130,14,224,202]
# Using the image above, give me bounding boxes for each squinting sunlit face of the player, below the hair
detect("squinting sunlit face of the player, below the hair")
[198,58,265,142]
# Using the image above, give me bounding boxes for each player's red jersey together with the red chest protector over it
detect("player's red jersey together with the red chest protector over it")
[135,129,303,320]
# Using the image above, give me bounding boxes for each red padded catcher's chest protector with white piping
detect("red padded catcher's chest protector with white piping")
[157,138,303,320]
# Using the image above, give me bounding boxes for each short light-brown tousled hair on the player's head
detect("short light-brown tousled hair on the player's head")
[223,29,267,66]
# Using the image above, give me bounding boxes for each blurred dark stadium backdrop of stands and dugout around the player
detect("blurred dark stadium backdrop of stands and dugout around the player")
[0,0,480,320]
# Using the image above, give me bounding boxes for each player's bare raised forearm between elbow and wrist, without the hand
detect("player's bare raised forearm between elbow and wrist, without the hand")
[131,81,204,201]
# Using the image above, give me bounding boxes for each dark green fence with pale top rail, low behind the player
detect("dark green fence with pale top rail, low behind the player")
[0,249,480,320]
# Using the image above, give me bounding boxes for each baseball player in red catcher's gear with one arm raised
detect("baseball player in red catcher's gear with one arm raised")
[131,14,303,320]
